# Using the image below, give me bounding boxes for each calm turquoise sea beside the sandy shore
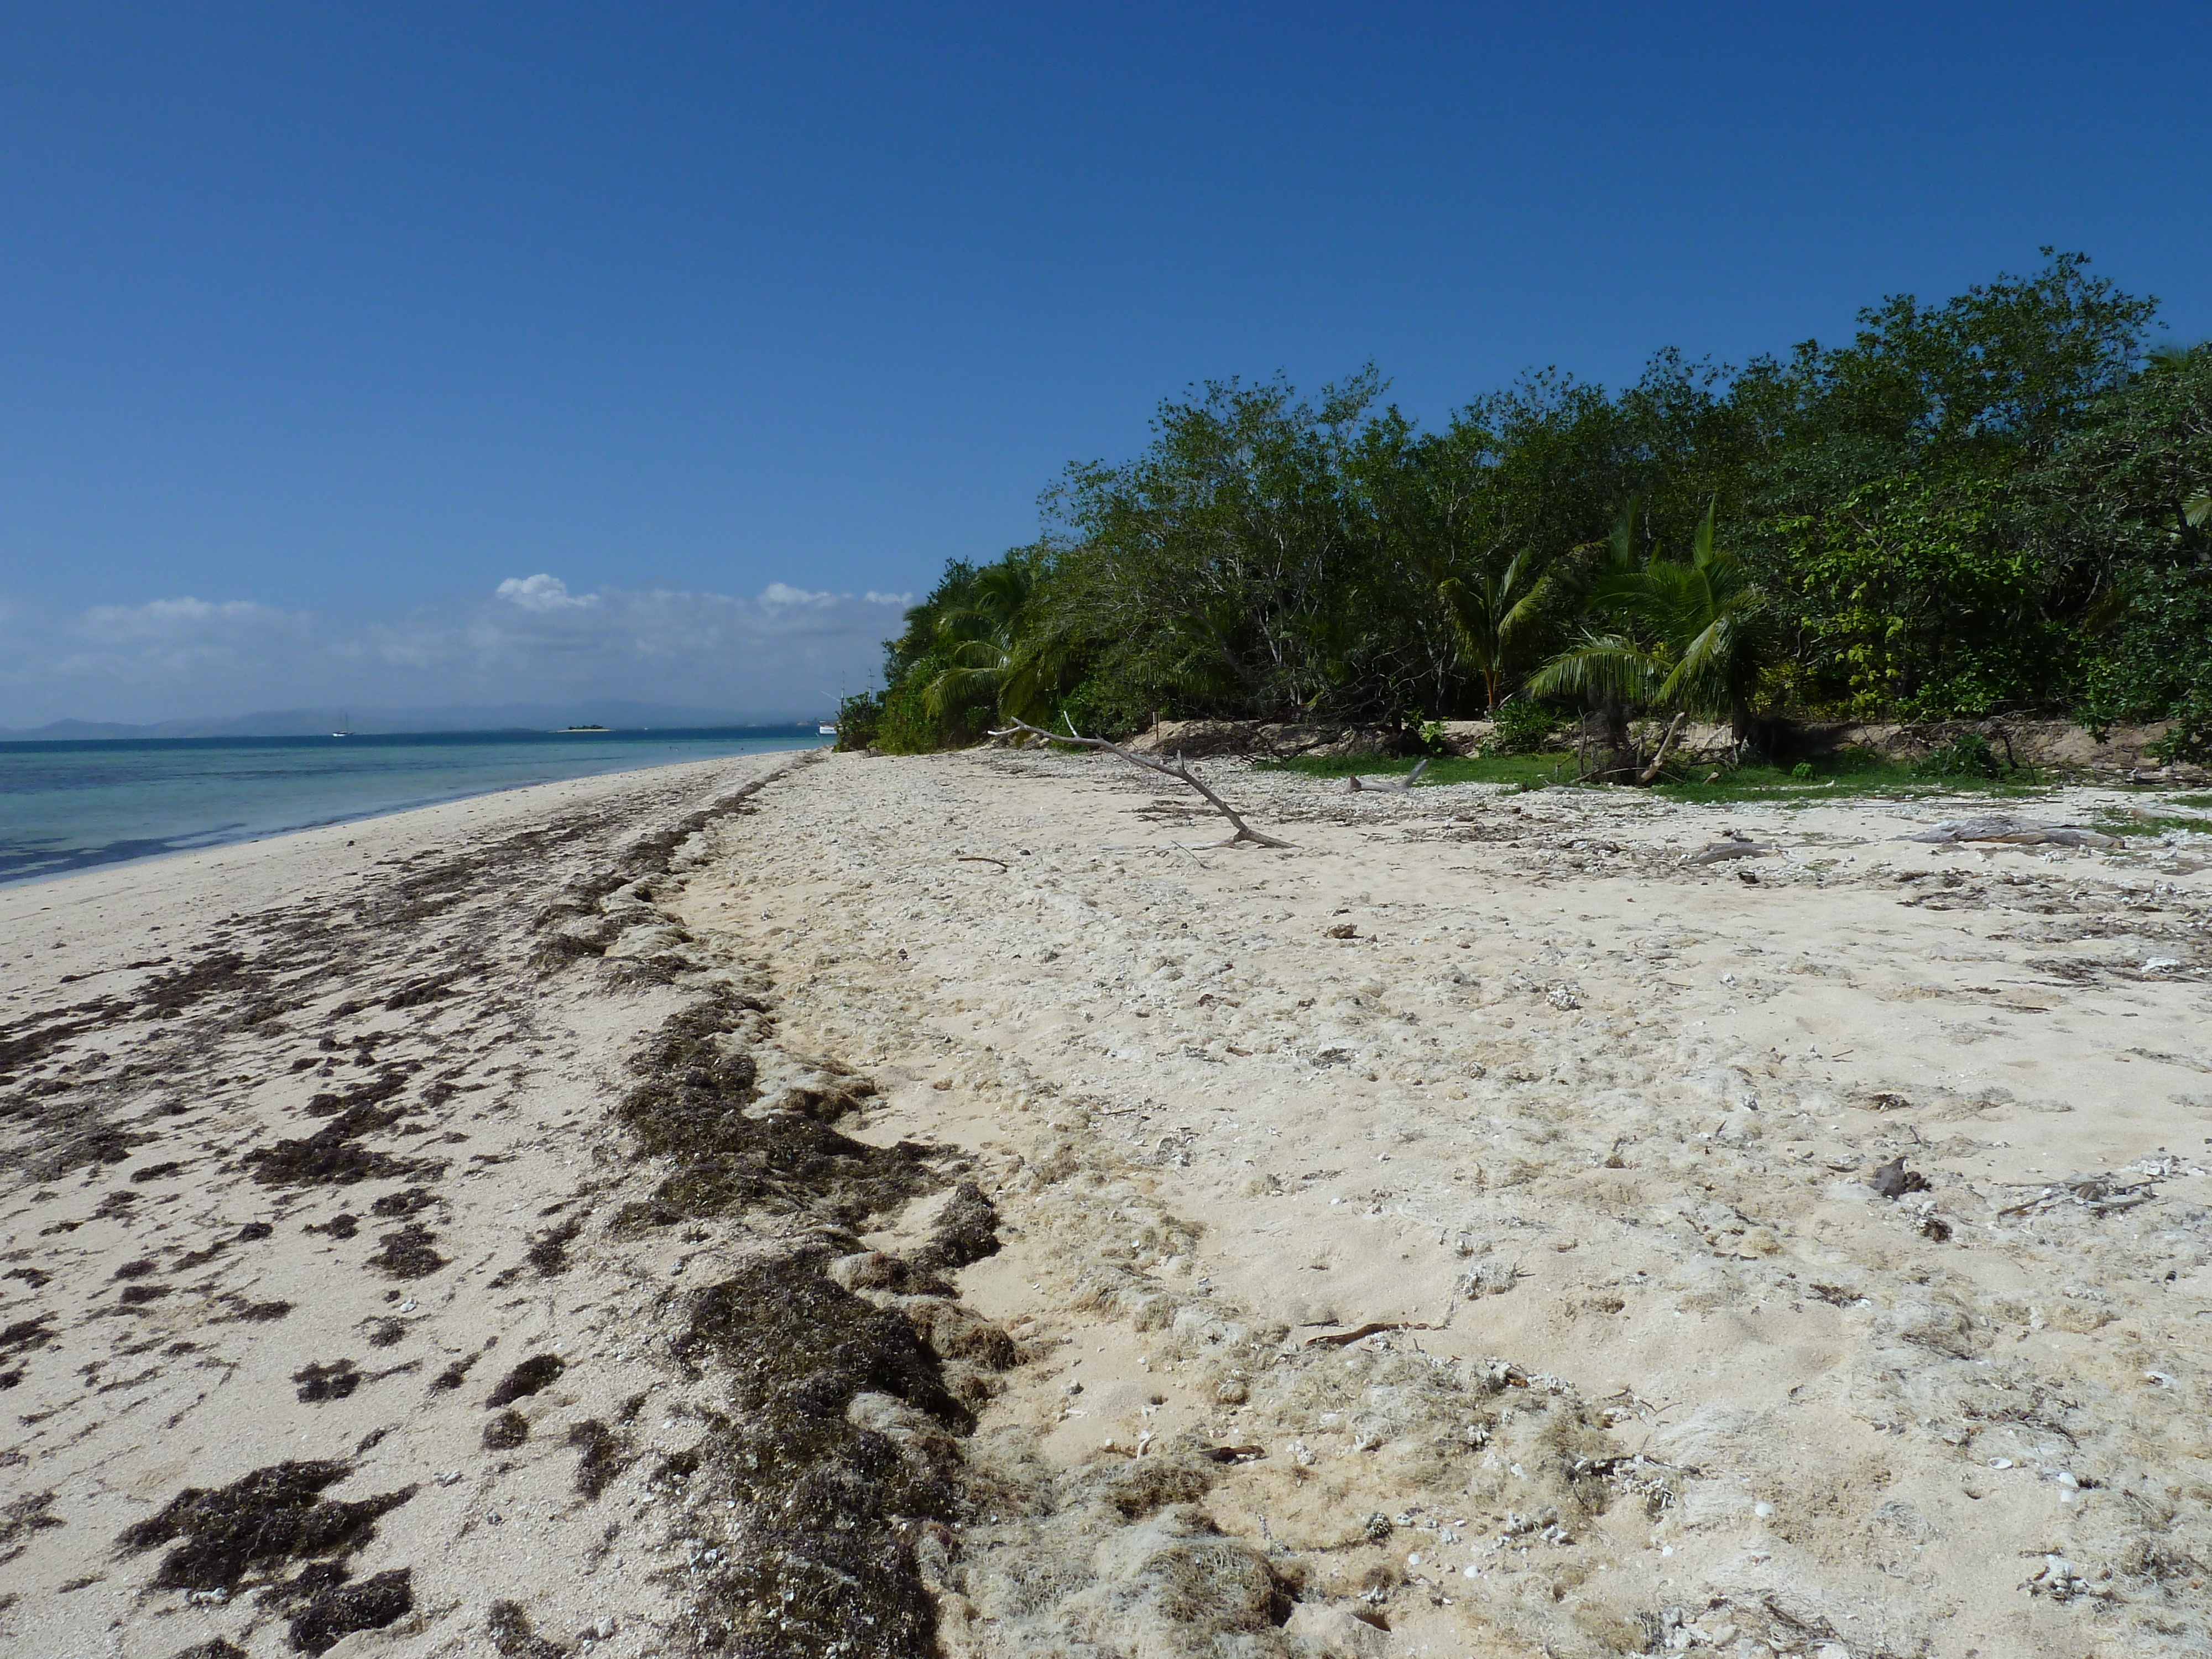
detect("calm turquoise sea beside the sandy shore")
[0,726,827,883]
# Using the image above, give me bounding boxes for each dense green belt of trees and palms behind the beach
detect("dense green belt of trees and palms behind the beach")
[841,250,2212,772]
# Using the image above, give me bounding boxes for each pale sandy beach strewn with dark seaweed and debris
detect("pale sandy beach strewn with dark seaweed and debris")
[0,754,2212,1659]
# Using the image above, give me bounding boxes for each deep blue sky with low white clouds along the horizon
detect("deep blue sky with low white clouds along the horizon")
[0,0,2212,726]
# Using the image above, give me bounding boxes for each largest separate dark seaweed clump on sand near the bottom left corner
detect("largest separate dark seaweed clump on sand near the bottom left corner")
[117,1460,416,1590]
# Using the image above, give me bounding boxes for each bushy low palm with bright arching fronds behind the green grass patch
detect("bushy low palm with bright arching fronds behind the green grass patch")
[1528,504,1774,779]
